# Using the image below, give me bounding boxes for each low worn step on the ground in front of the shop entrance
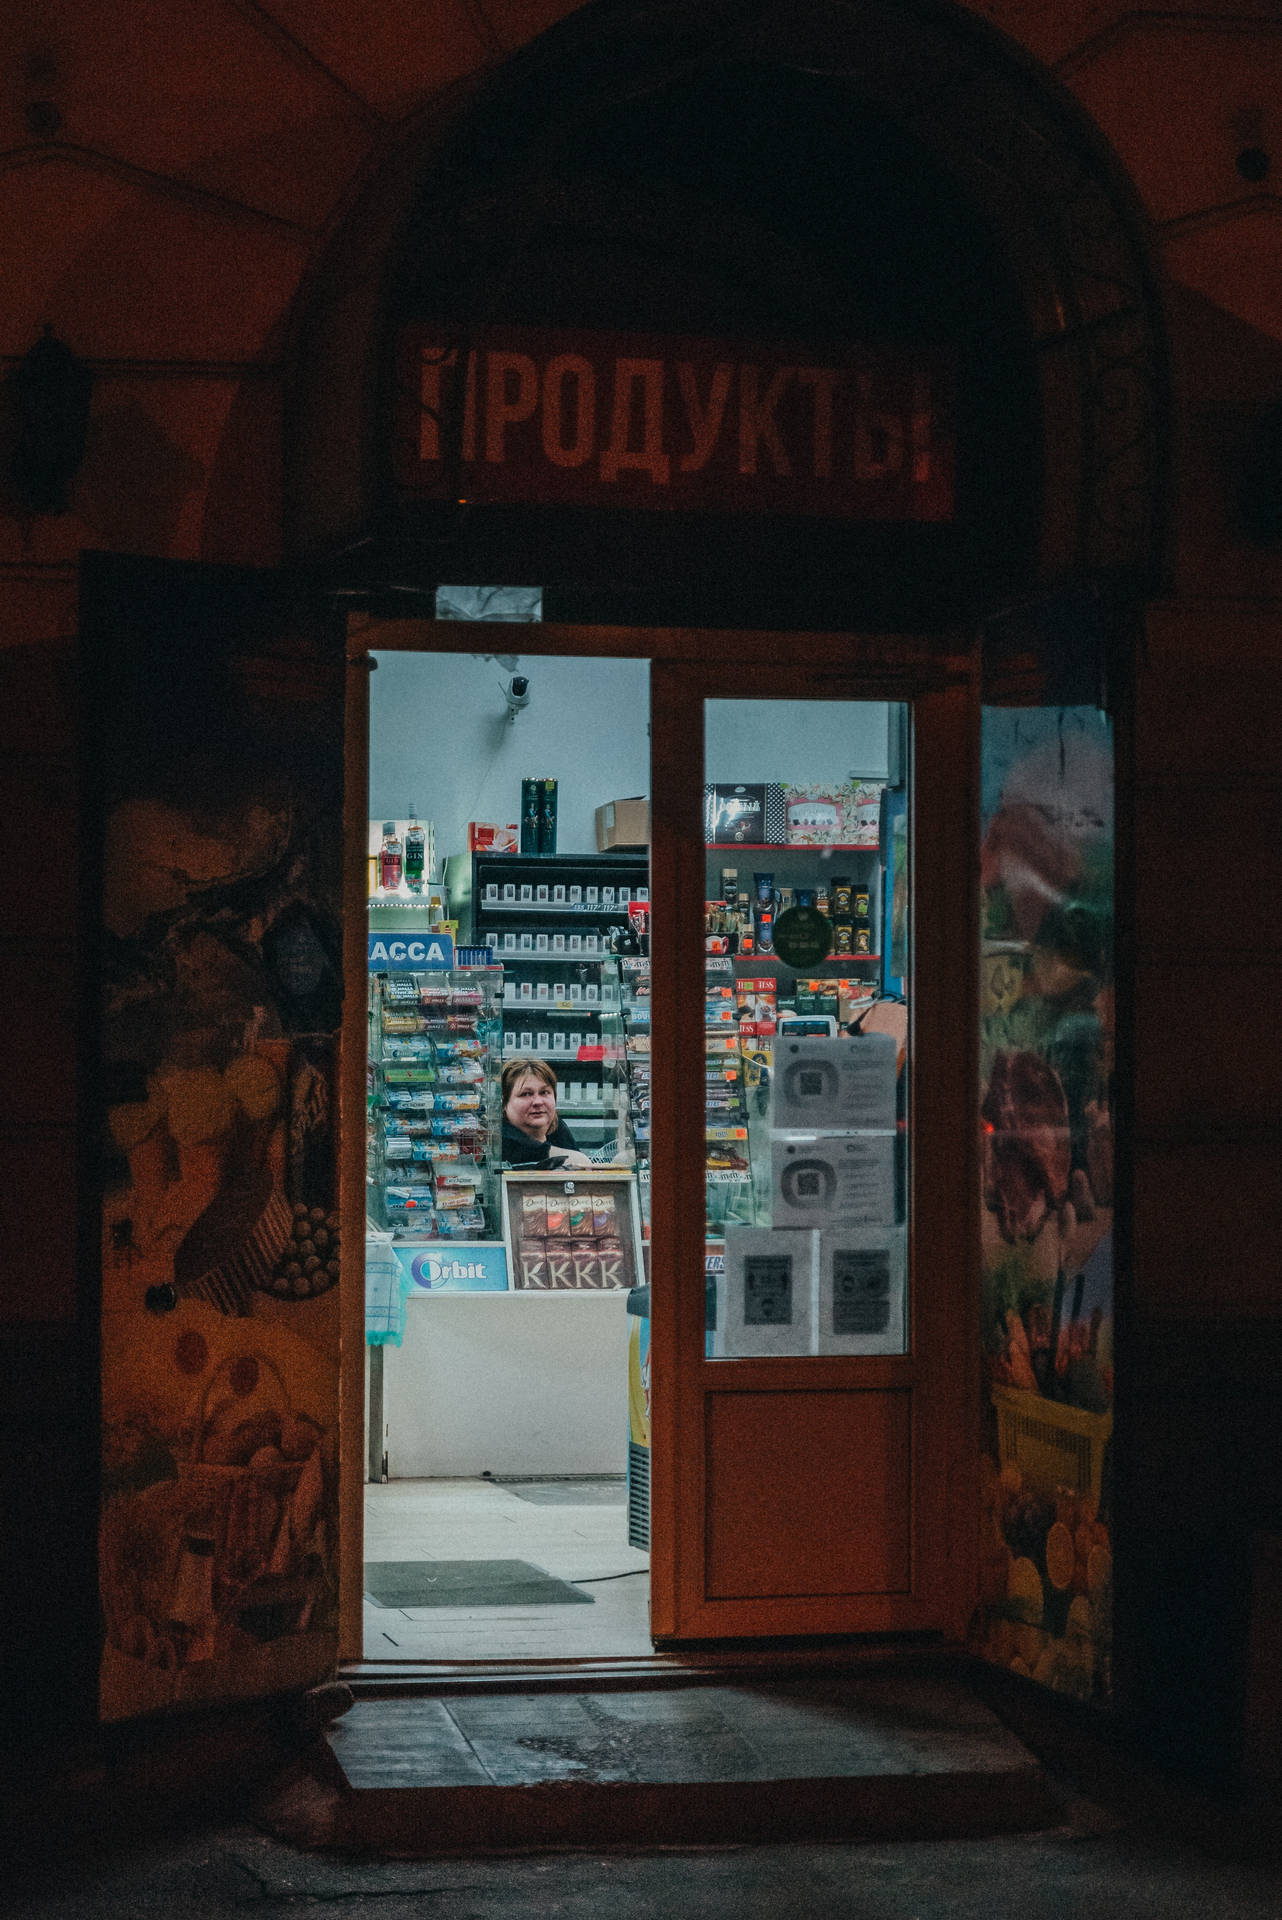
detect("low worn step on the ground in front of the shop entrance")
[310,1670,1061,1855]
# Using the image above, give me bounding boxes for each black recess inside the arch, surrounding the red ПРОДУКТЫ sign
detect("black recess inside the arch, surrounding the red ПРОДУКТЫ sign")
[380,41,1040,628]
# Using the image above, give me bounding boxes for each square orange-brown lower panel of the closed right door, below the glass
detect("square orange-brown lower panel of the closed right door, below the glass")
[704,1392,912,1599]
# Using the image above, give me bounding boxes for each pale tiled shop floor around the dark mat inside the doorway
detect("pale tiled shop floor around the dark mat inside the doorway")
[365,1480,651,1661]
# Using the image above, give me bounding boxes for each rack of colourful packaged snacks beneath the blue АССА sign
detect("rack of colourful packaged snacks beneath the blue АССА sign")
[368,966,503,1240]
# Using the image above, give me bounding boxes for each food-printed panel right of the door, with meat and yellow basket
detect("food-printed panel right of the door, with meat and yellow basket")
[973,707,1113,1705]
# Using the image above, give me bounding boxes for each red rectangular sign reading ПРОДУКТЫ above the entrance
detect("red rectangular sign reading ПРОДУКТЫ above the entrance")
[395,323,954,520]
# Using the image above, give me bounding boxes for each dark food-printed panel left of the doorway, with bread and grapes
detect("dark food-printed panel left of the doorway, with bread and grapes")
[98,572,342,1718]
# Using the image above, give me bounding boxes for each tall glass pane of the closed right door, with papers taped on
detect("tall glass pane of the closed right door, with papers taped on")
[704,699,912,1359]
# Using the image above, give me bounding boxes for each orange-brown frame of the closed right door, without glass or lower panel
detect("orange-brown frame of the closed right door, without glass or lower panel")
[651,652,979,1645]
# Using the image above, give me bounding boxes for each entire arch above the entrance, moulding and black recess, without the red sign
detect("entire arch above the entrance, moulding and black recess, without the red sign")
[94,8,1163,1720]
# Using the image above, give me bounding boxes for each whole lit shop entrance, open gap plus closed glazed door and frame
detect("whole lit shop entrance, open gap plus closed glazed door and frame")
[335,622,973,1663]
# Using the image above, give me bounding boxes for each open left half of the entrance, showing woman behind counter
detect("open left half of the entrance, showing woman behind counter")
[363,637,651,1661]
